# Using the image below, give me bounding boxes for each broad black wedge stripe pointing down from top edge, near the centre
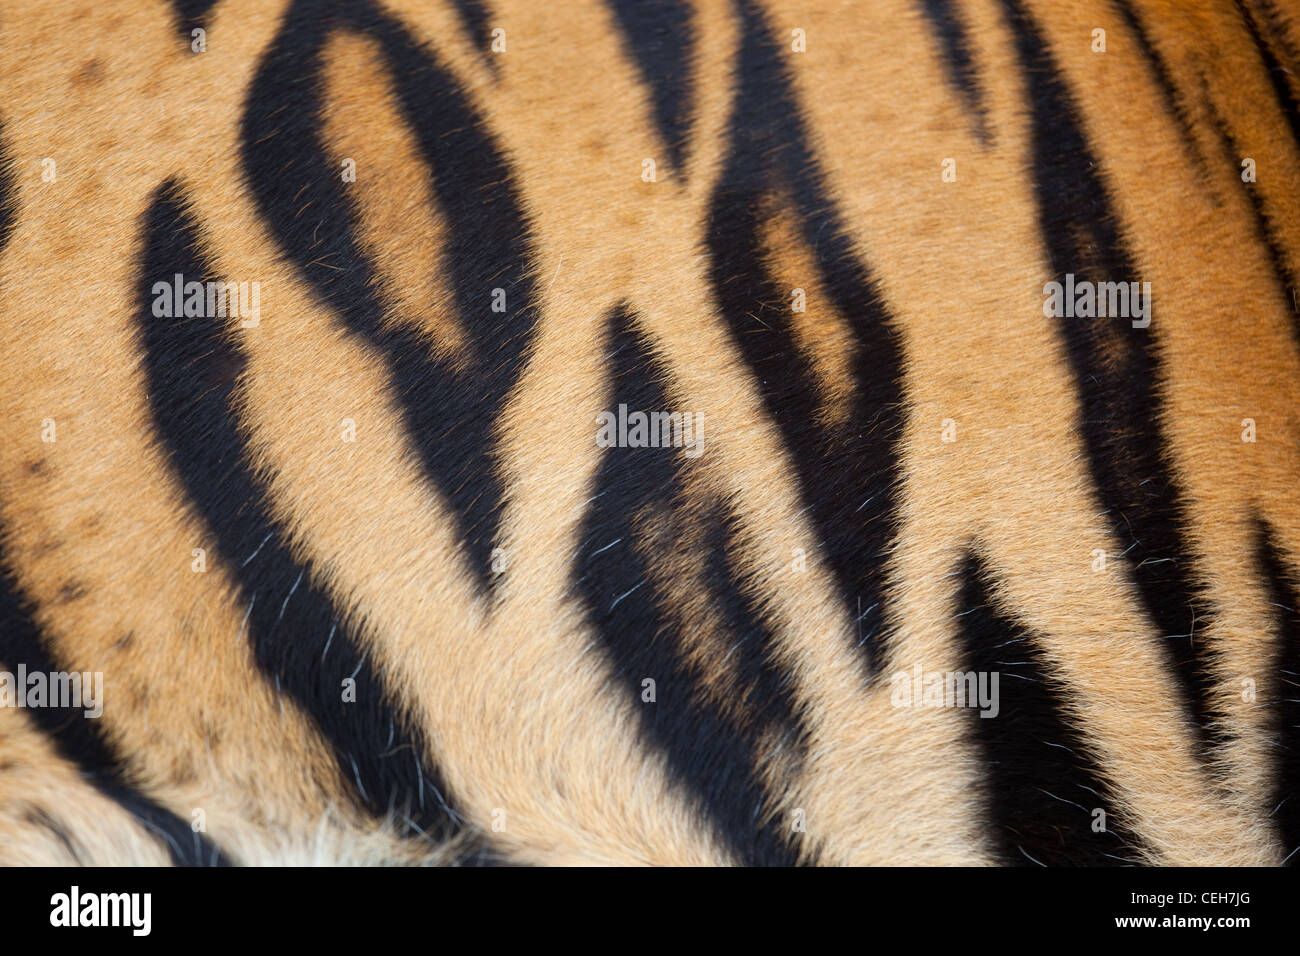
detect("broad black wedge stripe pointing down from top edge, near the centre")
[608,0,696,170]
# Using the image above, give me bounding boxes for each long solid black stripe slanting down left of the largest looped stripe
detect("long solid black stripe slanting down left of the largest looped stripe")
[138,182,459,839]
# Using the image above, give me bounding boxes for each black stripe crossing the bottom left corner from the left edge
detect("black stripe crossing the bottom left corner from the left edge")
[0,538,230,866]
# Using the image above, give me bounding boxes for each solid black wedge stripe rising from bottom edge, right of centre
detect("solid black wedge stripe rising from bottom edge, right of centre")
[956,551,1136,866]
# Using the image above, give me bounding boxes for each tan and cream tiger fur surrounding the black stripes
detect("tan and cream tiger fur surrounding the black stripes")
[0,0,1300,865]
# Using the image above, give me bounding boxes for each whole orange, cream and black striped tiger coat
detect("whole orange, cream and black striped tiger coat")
[0,0,1300,865]
